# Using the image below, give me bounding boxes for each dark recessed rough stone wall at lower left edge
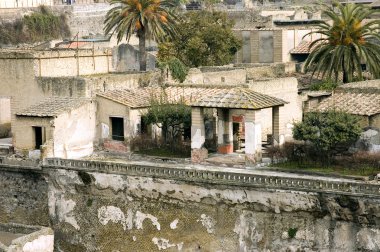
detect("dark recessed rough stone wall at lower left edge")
[0,168,50,226]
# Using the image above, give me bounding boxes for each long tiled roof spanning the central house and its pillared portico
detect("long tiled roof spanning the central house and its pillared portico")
[97,86,286,109]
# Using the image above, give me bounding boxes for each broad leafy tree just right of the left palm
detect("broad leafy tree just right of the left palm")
[158,11,241,67]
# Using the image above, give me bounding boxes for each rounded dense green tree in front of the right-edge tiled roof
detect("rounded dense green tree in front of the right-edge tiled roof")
[293,111,361,162]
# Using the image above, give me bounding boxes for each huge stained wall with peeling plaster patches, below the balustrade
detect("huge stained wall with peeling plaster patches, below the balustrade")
[49,167,380,251]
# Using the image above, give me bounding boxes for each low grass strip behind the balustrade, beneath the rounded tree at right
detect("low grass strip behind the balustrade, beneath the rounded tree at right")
[272,161,380,176]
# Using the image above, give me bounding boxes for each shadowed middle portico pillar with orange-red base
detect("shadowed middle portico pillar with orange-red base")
[218,109,233,154]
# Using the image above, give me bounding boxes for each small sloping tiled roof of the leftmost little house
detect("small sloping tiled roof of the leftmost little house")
[16,97,90,117]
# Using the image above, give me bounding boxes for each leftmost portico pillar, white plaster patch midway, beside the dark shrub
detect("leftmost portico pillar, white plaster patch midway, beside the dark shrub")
[191,107,208,163]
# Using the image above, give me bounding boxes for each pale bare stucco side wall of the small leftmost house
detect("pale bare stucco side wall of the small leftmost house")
[53,101,96,158]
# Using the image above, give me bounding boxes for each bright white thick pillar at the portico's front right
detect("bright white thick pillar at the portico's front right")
[245,110,262,165]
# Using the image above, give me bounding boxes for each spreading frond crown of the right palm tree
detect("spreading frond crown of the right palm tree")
[305,3,380,83]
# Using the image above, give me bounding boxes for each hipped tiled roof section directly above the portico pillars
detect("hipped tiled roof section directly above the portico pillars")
[192,88,287,109]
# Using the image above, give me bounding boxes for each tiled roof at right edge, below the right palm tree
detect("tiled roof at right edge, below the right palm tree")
[316,92,380,116]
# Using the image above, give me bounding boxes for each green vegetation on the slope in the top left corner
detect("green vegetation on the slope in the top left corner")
[0,6,70,44]
